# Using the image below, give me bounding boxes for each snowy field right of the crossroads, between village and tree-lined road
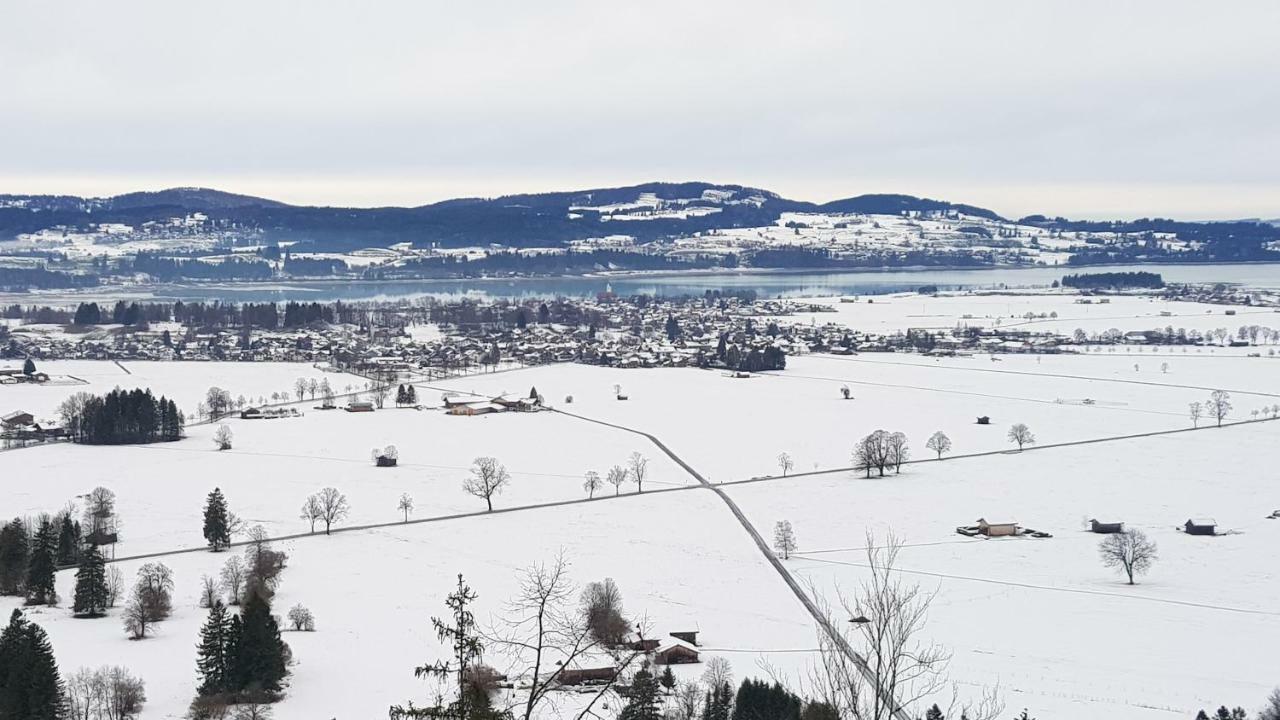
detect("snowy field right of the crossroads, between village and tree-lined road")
[422,354,1280,482]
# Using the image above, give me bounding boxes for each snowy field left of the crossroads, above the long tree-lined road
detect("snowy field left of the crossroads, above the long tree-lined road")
[0,409,691,556]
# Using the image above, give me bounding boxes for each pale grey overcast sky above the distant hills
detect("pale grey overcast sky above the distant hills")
[0,0,1280,219]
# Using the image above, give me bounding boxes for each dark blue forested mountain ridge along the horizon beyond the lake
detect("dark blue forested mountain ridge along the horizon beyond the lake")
[0,182,1280,261]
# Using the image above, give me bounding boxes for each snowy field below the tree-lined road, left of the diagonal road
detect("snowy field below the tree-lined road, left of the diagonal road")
[0,491,814,720]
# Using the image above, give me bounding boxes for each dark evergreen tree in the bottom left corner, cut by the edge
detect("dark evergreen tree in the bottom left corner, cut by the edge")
[0,610,67,720]
